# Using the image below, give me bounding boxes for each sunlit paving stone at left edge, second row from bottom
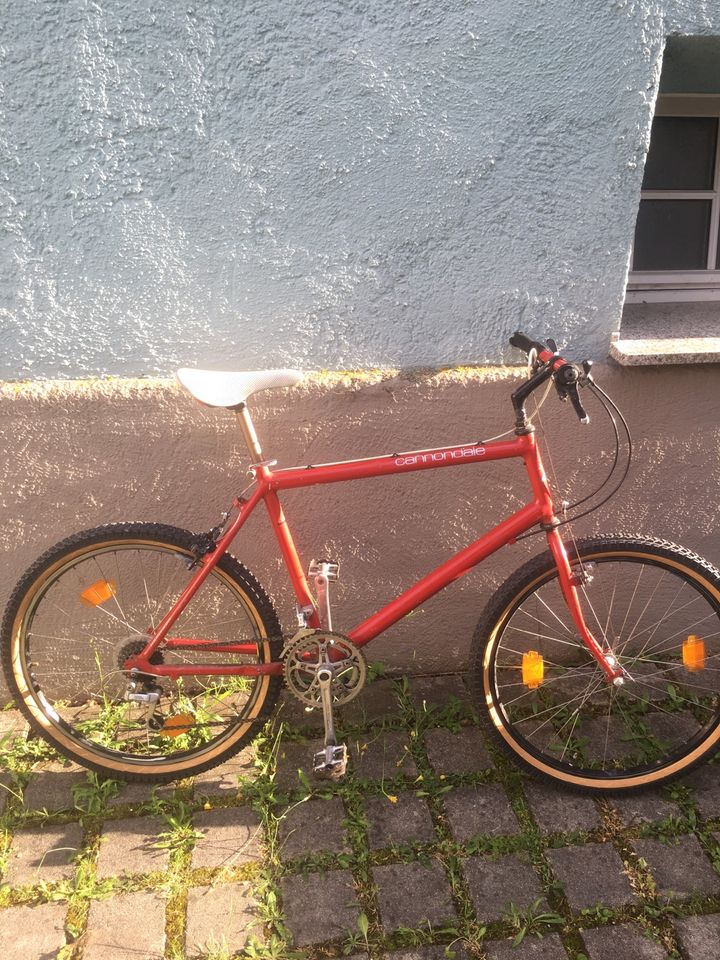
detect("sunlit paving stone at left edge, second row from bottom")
[5,823,82,887]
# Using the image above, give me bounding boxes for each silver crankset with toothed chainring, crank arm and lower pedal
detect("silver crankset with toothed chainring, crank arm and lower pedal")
[283,630,367,780]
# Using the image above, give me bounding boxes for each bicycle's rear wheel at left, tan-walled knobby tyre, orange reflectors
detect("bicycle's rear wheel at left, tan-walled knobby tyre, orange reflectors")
[2,523,282,782]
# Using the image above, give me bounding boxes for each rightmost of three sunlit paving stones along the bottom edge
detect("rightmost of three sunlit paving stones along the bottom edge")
[185,883,262,957]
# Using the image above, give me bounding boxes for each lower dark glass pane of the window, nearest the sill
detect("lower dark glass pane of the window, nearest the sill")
[633,200,712,270]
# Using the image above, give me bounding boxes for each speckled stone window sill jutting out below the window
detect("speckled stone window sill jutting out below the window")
[610,303,720,367]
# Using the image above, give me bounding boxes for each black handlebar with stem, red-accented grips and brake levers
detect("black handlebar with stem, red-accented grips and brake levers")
[510,330,592,434]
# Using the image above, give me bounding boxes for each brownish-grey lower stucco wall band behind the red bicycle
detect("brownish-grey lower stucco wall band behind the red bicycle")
[0,363,720,700]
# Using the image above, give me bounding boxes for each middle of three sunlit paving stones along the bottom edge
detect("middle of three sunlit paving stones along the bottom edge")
[83,891,165,960]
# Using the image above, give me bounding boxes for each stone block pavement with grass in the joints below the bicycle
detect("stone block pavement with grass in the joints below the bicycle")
[0,676,720,960]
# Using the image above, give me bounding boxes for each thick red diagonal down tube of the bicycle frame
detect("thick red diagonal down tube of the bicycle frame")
[348,503,543,647]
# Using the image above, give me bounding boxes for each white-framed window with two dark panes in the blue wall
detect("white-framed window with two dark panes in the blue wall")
[626,94,720,303]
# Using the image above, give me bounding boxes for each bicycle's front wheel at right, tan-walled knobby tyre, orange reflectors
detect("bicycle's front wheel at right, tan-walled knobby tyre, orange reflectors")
[472,537,720,792]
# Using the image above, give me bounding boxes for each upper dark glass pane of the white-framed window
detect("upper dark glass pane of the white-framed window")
[643,117,718,190]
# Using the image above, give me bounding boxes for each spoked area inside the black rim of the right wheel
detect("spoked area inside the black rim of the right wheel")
[493,554,720,780]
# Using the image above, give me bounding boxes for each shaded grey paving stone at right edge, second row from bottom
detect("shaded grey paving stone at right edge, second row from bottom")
[633,836,720,900]
